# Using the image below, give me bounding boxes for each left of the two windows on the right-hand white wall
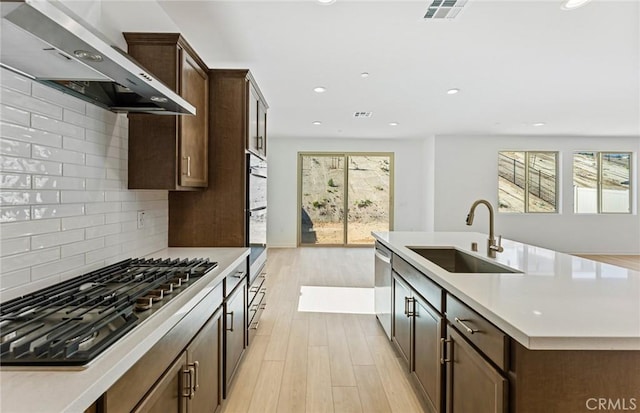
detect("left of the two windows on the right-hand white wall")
[498,151,558,213]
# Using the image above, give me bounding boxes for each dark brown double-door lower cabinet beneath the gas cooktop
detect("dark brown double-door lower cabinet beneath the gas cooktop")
[133,311,222,413]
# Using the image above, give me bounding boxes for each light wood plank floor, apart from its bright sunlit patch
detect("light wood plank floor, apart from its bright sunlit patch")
[223,248,422,413]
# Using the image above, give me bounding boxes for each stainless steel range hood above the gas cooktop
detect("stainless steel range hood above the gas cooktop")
[0,0,196,115]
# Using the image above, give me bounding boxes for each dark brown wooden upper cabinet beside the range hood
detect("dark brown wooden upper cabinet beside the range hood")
[124,33,209,190]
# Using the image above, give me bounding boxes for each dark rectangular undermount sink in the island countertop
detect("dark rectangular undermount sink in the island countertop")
[407,247,521,274]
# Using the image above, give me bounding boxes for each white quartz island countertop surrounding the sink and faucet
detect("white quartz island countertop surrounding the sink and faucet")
[373,232,640,350]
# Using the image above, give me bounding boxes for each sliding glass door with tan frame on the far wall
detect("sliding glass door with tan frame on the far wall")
[298,153,393,246]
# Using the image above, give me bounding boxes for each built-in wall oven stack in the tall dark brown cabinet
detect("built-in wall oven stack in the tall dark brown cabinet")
[247,154,267,273]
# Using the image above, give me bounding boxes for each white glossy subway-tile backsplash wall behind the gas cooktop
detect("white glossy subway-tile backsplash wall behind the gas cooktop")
[0,69,168,300]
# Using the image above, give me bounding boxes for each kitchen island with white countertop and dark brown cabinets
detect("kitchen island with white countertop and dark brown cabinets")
[373,232,640,413]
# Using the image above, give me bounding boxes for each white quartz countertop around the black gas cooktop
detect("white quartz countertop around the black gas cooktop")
[0,248,249,413]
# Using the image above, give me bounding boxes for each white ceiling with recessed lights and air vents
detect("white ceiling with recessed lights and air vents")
[97,0,640,138]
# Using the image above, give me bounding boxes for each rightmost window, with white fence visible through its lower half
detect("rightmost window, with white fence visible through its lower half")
[573,152,631,214]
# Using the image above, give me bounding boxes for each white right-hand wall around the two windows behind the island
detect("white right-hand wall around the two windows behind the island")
[435,136,640,254]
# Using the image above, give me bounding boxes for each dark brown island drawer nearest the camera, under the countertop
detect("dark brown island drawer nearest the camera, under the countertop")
[447,294,509,370]
